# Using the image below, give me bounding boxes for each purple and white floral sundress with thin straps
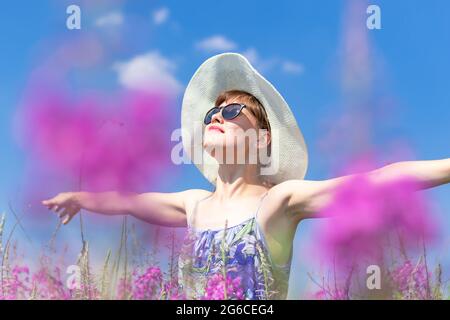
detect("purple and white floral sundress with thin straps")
[178,192,292,300]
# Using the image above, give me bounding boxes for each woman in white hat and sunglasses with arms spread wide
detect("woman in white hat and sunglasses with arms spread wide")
[42,53,450,299]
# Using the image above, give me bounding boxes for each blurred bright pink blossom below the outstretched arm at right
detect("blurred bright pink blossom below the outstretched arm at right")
[317,174,437,269]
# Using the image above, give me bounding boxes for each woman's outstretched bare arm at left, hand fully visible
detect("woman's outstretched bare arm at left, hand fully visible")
[42,190,207,227]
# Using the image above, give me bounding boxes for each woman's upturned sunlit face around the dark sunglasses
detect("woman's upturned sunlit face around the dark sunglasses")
[203,99,268,164]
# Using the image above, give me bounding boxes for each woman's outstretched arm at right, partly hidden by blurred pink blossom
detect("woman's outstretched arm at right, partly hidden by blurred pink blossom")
[273,158,450,221]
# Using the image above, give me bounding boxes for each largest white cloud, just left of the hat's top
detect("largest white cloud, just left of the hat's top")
[113,51,183,94]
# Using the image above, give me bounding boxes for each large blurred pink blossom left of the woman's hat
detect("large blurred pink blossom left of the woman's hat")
[21,90,170,190]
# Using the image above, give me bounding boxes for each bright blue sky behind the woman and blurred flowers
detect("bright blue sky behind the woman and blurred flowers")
[0,0,450,296]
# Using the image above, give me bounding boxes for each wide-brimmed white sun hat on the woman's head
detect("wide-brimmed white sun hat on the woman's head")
[181,53,308,184]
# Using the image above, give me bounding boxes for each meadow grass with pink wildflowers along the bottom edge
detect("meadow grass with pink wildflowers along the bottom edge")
[0,210,448,300]
